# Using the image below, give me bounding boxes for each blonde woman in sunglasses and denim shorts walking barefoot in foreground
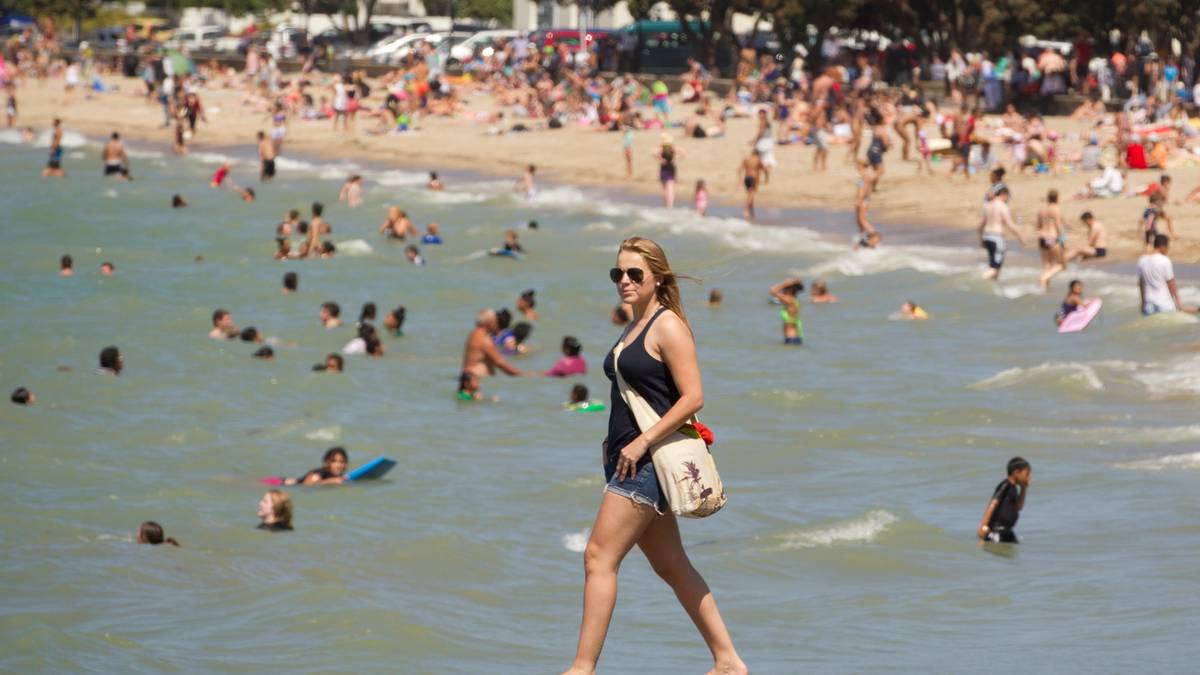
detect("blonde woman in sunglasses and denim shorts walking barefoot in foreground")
[566,237,748,675]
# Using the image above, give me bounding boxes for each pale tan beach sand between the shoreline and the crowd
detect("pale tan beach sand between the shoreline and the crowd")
[11,77,1200,263]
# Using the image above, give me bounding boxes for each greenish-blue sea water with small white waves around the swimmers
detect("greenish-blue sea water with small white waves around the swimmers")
[0,135,1200,674]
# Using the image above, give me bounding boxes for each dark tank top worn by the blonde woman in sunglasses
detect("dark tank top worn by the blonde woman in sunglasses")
[604,307,679,454]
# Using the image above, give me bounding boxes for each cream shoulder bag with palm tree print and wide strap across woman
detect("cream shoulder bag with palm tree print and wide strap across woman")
[612,344,726,518]
